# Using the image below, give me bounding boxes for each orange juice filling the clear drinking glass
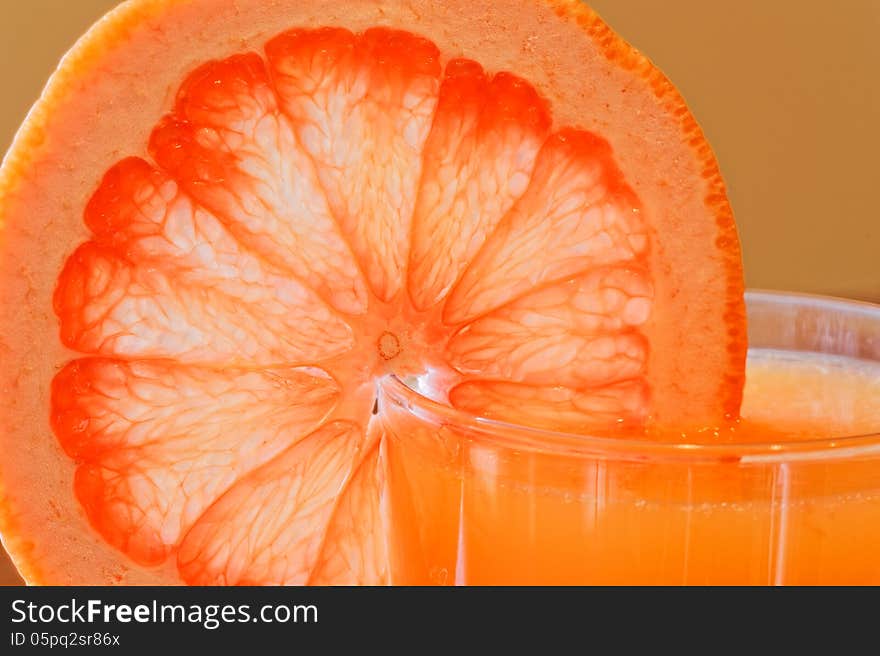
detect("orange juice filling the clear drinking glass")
[386,349,880,584]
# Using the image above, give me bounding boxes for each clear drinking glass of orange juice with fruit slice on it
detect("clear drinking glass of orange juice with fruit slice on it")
[379,292,880,585]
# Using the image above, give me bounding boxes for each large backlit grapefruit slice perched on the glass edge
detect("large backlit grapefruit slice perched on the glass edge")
[0,0,746,584]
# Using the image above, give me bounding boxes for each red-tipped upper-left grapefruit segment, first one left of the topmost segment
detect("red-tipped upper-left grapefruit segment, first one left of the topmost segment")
[150,53,367,314]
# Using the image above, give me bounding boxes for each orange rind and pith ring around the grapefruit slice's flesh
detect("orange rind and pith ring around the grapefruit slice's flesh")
[0,0,746,584]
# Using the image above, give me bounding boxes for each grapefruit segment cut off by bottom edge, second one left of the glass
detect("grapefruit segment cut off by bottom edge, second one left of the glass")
[178,422,364,585]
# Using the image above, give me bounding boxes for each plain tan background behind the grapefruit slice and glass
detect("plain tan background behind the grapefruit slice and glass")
[0,0,880,583]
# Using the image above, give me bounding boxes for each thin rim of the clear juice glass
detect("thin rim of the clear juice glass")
[379,289,880,464]
